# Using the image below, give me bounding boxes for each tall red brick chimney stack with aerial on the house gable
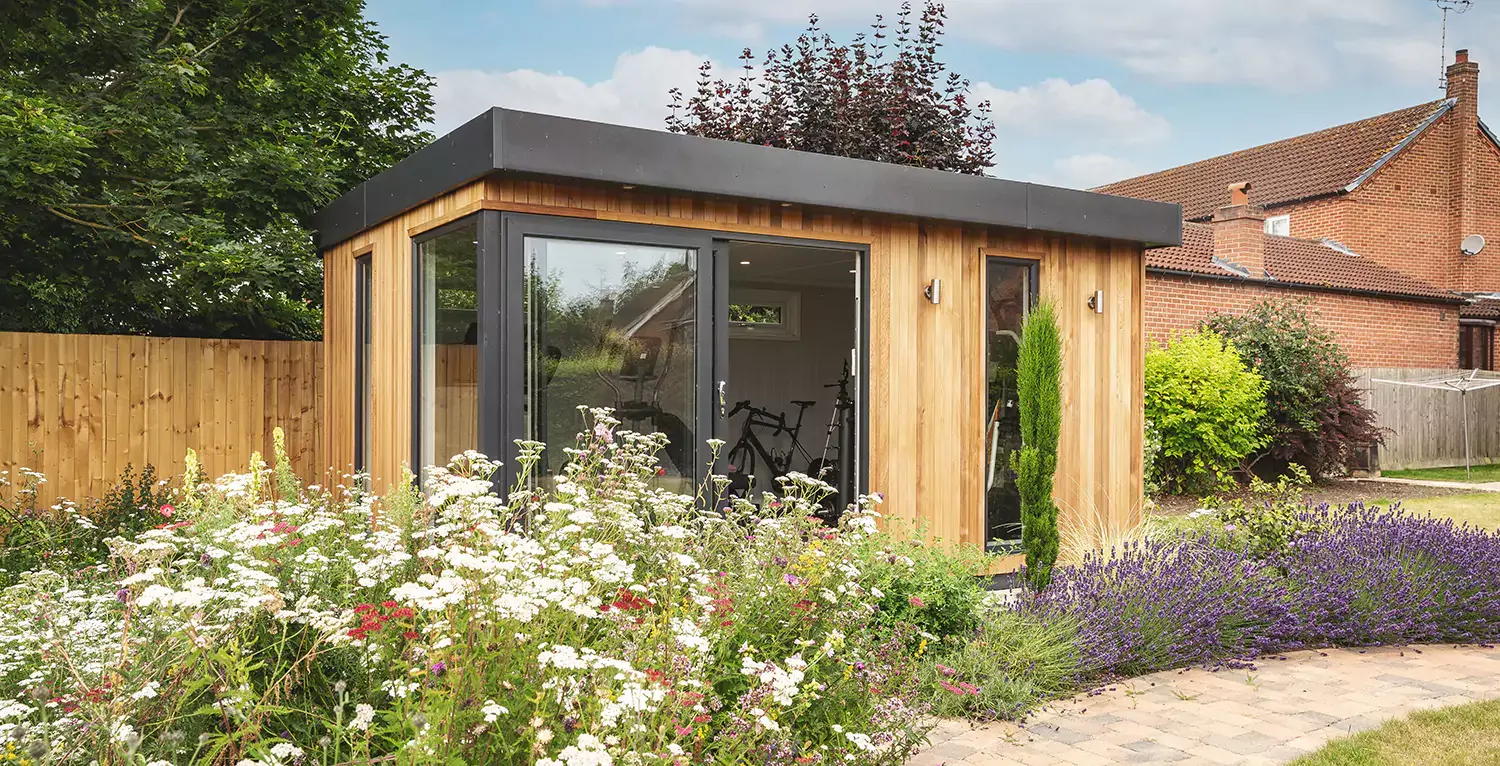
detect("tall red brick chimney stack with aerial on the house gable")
[1445,49,1485,291]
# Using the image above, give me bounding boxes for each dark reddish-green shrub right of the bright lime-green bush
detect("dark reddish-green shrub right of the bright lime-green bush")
[1205,300,1383,478]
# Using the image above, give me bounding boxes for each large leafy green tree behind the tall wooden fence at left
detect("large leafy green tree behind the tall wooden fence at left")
[0,0,432,337]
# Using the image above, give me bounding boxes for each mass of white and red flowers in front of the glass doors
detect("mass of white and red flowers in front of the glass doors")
[0,411,975,766]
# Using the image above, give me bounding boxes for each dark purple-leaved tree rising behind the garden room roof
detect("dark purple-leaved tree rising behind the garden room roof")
[666,0,995,174]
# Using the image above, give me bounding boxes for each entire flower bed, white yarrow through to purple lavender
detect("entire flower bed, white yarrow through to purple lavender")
[0,411,1500,766]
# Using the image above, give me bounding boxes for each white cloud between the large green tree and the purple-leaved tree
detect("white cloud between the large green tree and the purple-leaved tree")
[434,46,708,135]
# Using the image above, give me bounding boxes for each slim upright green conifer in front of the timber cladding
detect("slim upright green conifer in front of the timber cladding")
[1011,301,1062,591]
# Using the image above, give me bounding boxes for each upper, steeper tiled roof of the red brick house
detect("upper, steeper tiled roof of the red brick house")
[1094,99,1452,220]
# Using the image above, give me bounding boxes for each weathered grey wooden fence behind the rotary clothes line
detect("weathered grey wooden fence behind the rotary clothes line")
[1358,369,1500,471]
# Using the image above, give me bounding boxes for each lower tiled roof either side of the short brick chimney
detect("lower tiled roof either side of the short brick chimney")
[1146,223,1458,303]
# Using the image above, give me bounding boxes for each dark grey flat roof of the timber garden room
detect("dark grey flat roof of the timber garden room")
[314,106,1182,247]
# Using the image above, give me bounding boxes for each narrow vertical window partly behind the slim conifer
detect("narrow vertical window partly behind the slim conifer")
[984,258,1037,549]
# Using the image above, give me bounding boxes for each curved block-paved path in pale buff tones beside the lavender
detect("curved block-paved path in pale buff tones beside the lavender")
[908,646,1500,766]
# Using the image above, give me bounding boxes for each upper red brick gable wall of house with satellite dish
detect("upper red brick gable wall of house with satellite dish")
[1266,112,1500,292]
